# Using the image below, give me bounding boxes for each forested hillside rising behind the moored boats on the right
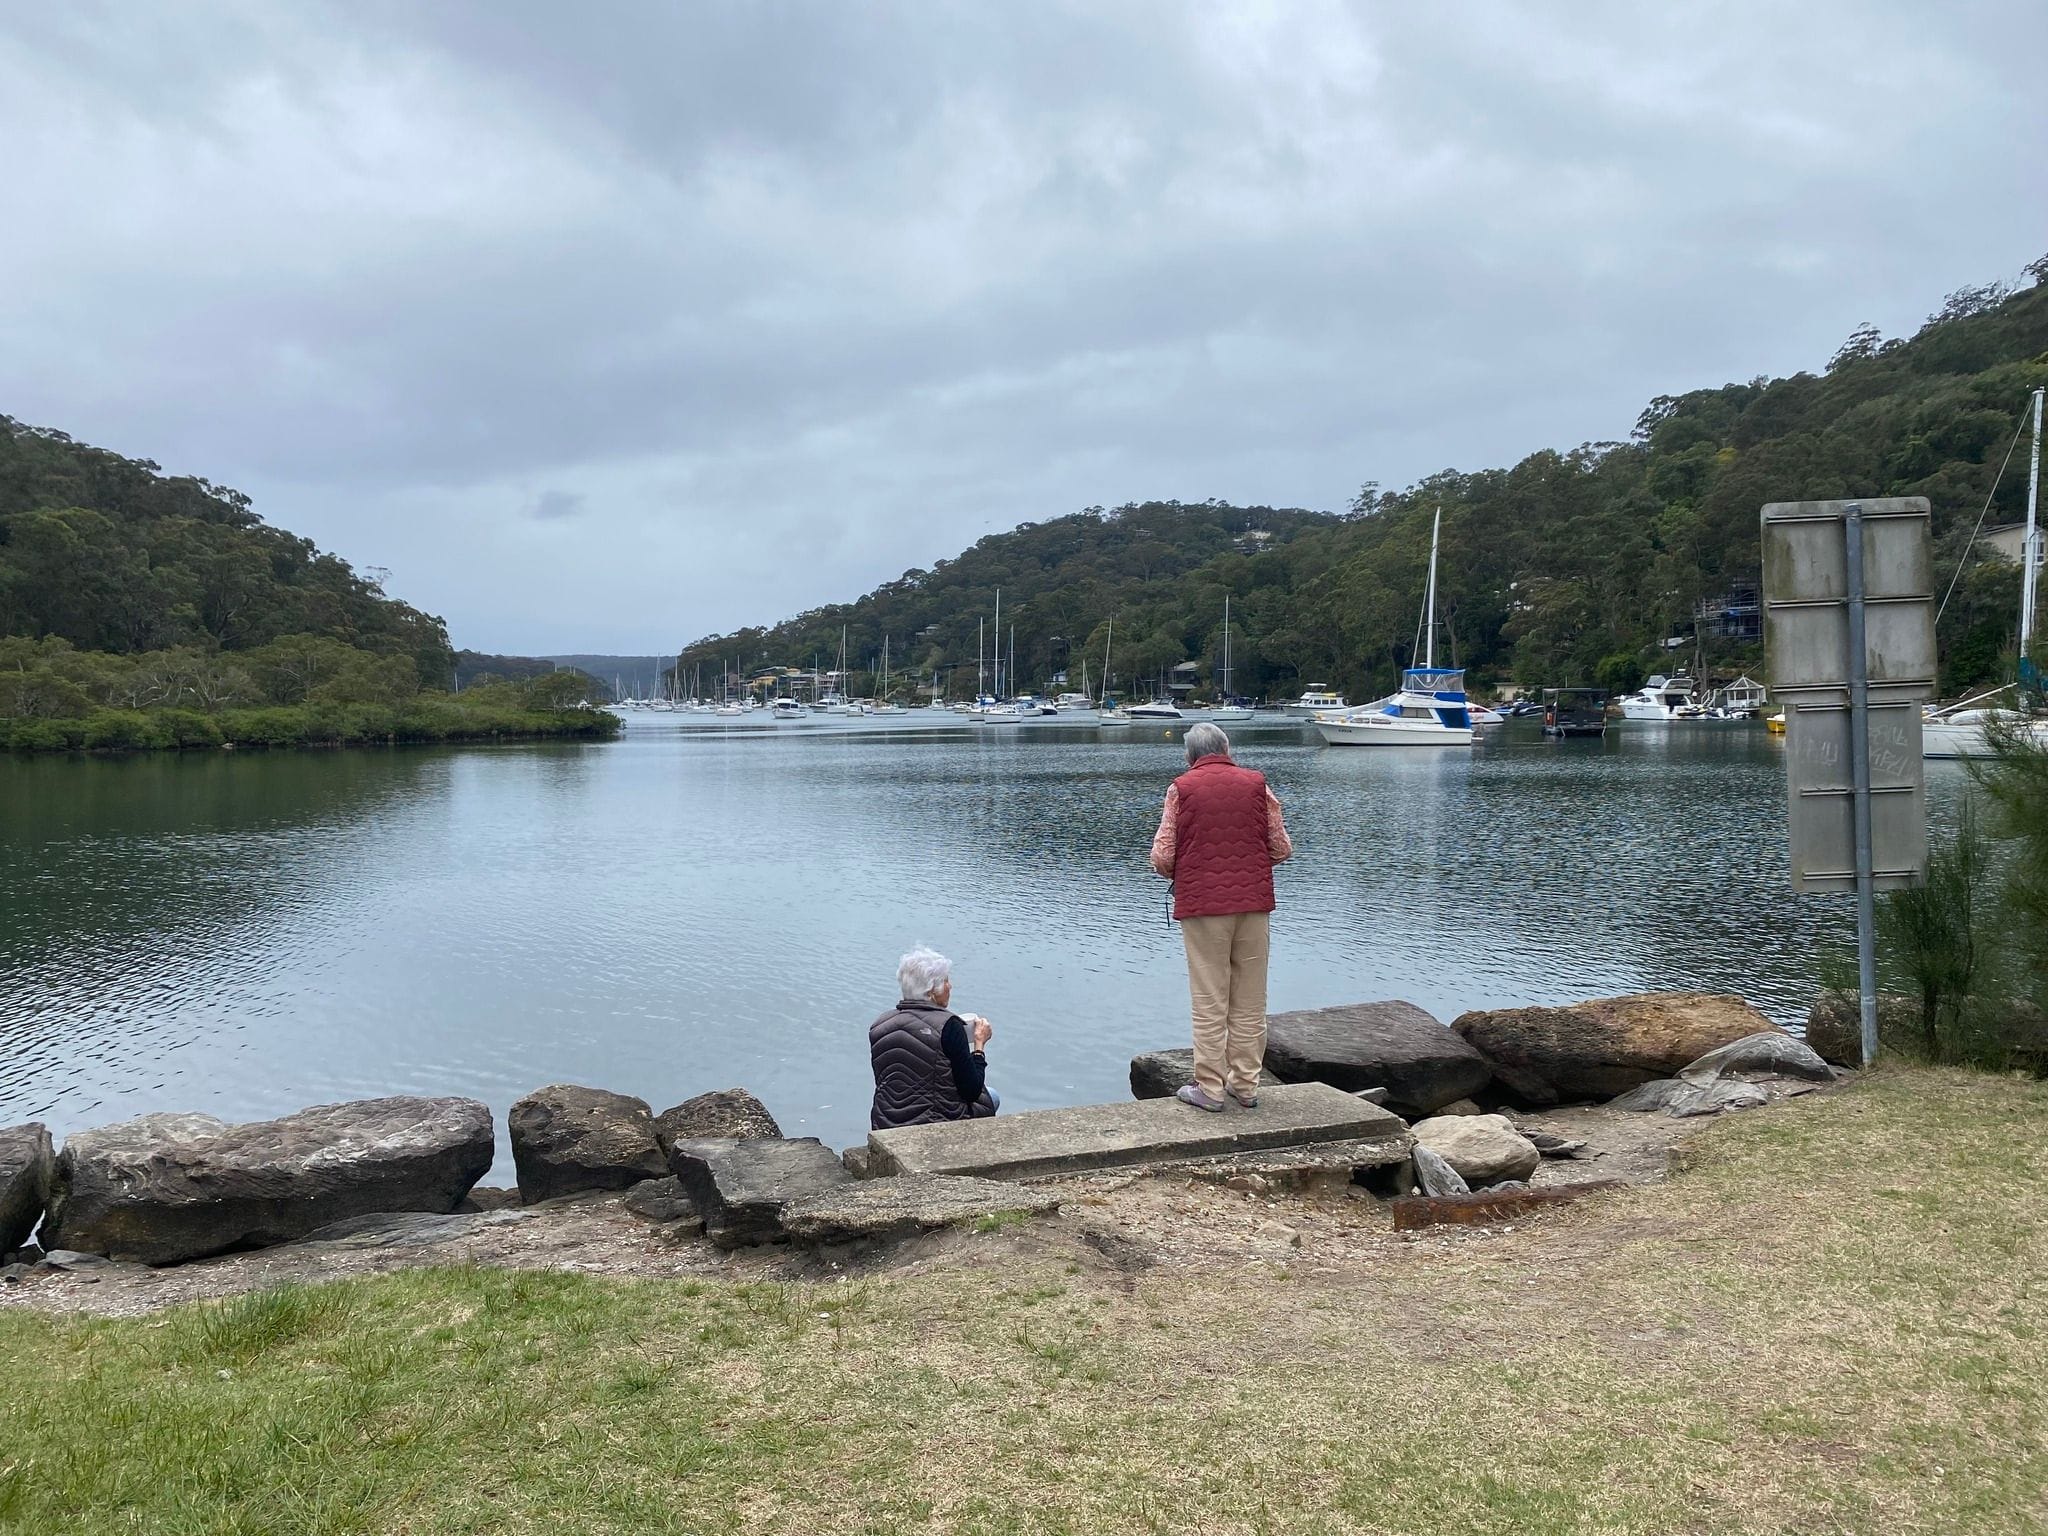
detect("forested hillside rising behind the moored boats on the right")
[680,258,2048,696]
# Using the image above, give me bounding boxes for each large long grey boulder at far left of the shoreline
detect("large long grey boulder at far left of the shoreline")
[45,1098,494,1264]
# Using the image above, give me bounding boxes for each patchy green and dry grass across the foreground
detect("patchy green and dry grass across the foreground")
[0,1071,2048,1536]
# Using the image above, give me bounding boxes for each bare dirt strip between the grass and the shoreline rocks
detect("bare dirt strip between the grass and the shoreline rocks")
[0,1108,1710,1317]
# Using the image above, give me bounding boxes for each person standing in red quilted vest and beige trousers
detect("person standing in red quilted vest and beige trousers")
[1151,721,1294,1110]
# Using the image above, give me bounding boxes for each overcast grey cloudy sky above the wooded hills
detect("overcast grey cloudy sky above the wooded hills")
[0,0,2048,653]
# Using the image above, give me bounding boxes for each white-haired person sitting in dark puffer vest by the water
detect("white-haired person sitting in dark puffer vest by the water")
[868,948,995,1130]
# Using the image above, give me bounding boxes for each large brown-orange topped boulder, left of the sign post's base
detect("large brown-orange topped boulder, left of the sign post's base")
[1450,991,1782,1104]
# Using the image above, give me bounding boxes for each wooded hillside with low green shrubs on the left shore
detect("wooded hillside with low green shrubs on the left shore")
[0,416,612,750]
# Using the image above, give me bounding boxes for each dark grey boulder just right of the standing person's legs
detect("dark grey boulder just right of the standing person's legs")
[1266,1001,1493,1118]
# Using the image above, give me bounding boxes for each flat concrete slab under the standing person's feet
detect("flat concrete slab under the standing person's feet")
[868,1083,1407,1180]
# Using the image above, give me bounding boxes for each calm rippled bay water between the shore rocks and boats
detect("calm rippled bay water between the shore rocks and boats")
[0,717,1960,1171]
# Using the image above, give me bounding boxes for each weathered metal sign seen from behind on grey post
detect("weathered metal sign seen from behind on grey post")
[1763,496,1935,1065]
